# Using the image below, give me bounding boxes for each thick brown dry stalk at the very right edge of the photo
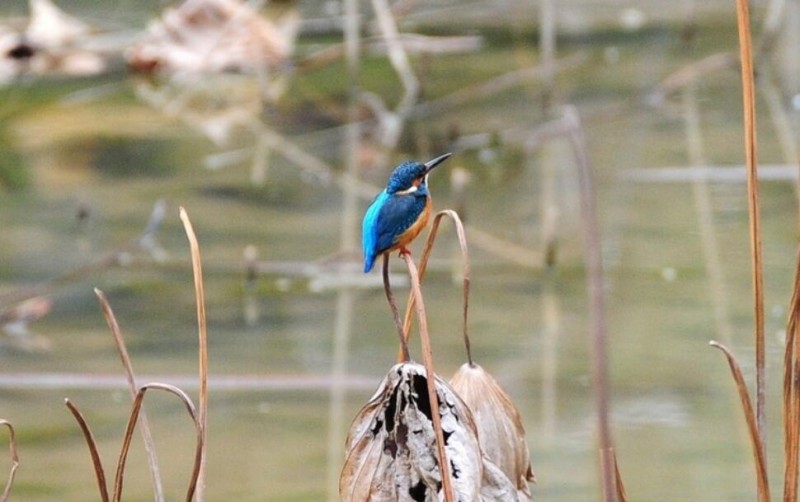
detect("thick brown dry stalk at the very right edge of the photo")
[783,248,800,502]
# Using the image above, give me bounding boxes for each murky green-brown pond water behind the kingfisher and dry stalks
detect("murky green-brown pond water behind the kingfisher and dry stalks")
[0,1,798,501]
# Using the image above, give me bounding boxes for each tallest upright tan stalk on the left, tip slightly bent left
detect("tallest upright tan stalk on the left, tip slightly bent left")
[180,207,208,502]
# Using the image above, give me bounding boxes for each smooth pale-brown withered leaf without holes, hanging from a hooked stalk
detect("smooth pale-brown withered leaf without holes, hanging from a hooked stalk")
[450,364,536,500]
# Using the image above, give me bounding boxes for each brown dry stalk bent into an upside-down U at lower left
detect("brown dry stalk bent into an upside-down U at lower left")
[112,383,205,502]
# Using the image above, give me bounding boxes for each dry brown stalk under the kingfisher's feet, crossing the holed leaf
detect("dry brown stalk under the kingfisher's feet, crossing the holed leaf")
[400,253,455,502]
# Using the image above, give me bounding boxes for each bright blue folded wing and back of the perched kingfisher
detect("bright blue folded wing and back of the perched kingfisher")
[361,191,425,272]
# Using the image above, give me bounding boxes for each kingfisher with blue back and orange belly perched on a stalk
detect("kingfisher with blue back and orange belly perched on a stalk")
[361,153,452,273]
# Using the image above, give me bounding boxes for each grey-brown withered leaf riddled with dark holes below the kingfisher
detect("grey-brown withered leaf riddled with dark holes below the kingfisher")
[339,363,517,502]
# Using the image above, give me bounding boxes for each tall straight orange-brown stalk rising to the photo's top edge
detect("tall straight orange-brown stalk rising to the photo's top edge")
[736,0,767,457]
